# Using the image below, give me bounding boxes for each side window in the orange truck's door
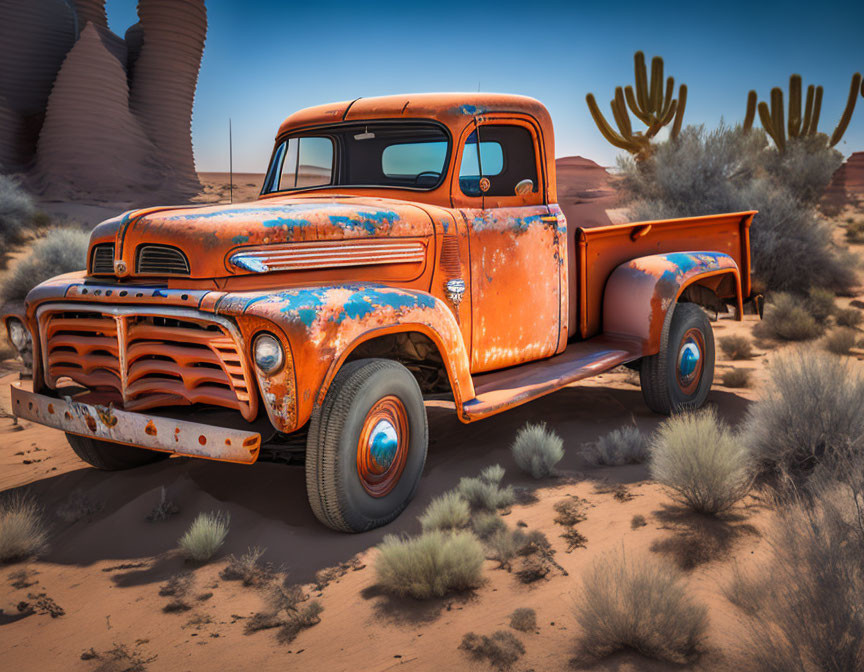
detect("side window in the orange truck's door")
[459,125,539,197]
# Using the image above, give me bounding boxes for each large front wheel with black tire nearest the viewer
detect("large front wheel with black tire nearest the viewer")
[306,359,429,532]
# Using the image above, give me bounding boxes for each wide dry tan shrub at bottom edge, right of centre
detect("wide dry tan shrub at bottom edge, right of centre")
[576,553,708,663]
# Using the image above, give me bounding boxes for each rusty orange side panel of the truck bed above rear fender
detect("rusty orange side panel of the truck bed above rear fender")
[570,210,756,338]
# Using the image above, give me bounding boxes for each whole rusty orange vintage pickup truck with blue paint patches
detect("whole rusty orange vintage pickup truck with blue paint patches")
[6,94,755,532]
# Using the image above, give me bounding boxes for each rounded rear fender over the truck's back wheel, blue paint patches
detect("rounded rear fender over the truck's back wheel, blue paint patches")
[603,252,742,355]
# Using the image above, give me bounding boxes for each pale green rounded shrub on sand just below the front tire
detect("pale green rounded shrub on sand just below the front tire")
[375,530,484,600]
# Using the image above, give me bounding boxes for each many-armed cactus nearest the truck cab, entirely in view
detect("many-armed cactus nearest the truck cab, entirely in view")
[585,51,687,159]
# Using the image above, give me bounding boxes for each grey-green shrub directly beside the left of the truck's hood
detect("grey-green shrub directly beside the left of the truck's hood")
[0,229,90,301]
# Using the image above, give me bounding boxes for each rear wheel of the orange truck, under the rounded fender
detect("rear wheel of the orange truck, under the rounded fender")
[639,303,714,415]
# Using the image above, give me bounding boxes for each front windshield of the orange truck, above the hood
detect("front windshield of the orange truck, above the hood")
[263,122,450,194]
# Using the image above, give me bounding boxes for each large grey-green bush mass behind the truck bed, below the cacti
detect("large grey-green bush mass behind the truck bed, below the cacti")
[619,125,856,294]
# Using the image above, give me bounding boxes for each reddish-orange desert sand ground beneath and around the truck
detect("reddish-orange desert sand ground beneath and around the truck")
[0,161,864,672]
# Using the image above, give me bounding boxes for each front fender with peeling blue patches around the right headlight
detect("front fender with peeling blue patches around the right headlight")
[216,283,474,432]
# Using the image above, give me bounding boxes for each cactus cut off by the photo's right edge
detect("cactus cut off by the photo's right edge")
[744,72,864,152]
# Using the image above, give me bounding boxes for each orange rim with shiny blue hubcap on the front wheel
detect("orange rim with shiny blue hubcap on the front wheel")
[357,395,408,497]
